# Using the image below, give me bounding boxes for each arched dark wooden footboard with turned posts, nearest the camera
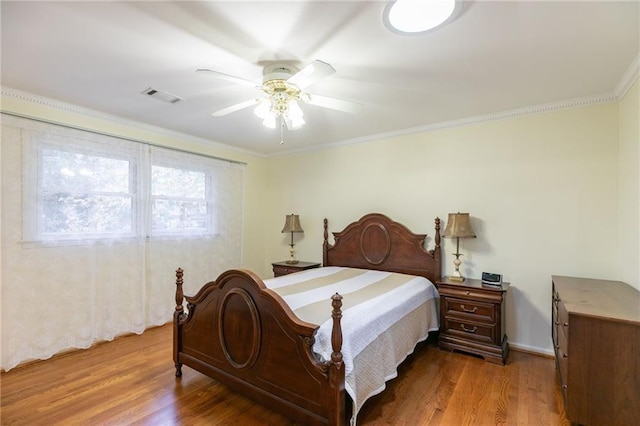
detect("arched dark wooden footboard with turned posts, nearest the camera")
[173,269,345,425]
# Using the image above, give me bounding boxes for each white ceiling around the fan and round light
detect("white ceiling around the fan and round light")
[0,0,640,154]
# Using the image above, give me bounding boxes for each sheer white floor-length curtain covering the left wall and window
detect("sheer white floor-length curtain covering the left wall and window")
[0,114,244,370]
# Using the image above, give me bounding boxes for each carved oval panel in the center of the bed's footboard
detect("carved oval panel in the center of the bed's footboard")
[218,288,261,369]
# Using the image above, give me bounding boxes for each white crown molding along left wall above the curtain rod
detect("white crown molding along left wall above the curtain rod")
[0,86,266,158]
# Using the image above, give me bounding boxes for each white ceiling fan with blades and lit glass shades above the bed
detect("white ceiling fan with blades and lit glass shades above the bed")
[197,60,362,129]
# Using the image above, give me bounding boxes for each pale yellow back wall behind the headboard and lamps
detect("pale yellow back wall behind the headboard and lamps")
[265,104,620,353]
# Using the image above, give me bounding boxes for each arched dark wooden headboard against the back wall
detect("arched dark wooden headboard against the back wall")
[322,213,442,284]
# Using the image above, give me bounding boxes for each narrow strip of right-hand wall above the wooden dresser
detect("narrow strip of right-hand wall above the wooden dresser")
[618,80,640,292]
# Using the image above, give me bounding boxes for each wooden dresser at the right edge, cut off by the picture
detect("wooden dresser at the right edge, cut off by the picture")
[551,276,640,426]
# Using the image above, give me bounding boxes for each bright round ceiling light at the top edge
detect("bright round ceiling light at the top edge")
[383,0,462,34]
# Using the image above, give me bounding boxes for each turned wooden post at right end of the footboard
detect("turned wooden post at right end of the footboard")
[325,292,345,425]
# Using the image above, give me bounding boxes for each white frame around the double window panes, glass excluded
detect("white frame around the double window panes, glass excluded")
[23,130,220,245]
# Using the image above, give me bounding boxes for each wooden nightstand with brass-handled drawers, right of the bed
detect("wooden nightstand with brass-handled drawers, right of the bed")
[437,277,509,364]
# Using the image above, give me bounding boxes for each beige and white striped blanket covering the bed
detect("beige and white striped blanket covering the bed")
[264,266,439,424]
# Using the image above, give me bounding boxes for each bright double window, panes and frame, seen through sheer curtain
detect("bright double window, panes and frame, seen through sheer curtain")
[25,127,240,242]
